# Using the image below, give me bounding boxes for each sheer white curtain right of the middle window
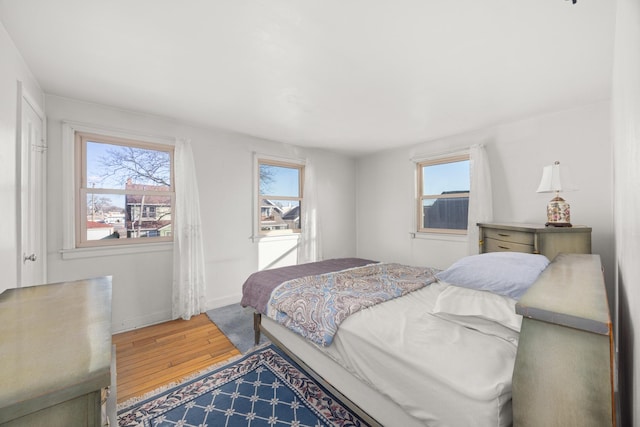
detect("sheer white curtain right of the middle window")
[298,160,322,264]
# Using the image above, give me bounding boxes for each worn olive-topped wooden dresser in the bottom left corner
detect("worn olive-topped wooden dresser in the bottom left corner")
[0,277,112,427]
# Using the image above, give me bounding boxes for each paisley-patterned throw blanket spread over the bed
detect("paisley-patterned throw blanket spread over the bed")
[267,263,440,346]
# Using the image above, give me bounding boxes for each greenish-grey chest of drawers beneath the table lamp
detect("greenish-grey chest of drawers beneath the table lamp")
[478,223,591,260]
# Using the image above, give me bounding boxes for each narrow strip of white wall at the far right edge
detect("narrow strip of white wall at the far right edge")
[613,0,640,426]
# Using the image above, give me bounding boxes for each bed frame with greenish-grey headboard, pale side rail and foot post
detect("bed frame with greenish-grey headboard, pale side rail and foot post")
[254,254,616,427]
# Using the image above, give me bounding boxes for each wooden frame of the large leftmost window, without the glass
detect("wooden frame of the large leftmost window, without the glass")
[73,129,176,250]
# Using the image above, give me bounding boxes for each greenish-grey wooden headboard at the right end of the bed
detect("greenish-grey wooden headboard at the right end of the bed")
[513,254,616,427]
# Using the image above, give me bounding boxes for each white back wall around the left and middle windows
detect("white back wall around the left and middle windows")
[46,96,355,332]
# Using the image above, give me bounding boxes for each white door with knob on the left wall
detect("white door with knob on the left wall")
[18,84,47,286]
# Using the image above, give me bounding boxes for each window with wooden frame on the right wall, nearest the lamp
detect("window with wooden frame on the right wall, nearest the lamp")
[418,155,471,234]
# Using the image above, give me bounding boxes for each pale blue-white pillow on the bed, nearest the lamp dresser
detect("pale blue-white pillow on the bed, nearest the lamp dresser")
[436,252,549,299]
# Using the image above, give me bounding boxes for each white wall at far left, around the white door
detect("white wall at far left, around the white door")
[0,23,44,292]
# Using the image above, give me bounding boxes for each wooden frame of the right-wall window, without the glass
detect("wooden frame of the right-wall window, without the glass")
[416,152,471,235]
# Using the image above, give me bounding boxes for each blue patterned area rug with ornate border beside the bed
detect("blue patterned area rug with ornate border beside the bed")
[118,345,368,427]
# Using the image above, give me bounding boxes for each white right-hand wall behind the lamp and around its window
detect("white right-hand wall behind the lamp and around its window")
[357,102,614,289]
